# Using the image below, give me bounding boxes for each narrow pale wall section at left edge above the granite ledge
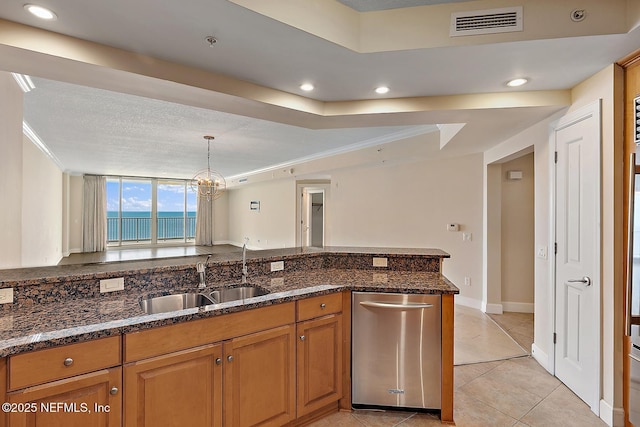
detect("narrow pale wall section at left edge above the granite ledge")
[0,72,23,268]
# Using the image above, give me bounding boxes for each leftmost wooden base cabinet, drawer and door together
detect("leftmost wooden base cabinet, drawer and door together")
[6,336,122,427]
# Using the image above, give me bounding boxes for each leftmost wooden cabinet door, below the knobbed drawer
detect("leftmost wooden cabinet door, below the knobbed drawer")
[7,367,122,427]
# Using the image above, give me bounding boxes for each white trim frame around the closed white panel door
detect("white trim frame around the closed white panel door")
[548,99,602,416]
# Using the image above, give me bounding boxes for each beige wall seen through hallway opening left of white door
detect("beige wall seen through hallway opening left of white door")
[501,153,535,313]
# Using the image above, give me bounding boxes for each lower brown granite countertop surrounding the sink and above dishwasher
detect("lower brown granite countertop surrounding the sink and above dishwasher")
[0,270,459,357]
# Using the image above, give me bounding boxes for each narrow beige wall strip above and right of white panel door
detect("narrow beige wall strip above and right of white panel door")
[571,65,626,425]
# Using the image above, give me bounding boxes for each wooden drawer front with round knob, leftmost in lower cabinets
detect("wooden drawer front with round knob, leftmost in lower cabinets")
[9,336,122,390]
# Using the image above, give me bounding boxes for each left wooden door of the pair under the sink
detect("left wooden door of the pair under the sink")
[124,344,222,427]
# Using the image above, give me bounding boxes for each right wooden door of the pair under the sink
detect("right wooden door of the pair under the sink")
[224,325,296,427]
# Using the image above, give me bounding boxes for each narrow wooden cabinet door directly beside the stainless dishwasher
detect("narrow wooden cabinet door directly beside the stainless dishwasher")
[297,314,342,416]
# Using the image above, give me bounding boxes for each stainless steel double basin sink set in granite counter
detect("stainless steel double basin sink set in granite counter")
[140,286,268,314]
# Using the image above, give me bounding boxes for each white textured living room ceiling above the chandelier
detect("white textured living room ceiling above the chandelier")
[24,78,437,178]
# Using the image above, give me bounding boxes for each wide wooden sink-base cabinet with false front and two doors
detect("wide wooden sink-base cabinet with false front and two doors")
[124,302,296,427]
